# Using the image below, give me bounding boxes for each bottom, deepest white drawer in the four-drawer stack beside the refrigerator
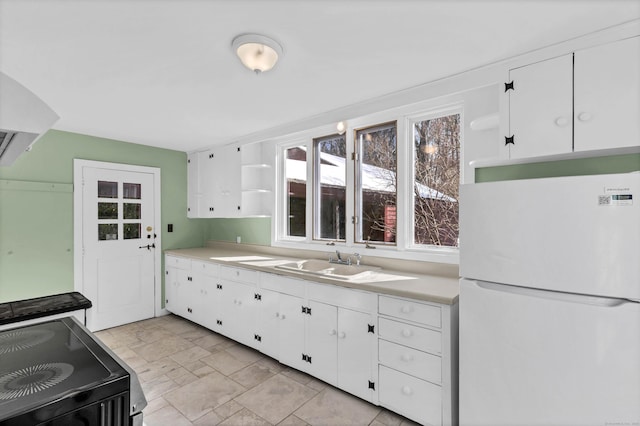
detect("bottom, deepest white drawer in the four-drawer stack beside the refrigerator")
[378,365,442,426]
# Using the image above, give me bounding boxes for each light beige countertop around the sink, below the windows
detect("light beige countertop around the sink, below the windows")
[165,247,460,305]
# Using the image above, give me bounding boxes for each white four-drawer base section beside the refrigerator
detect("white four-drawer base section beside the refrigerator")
[378,295,458,426]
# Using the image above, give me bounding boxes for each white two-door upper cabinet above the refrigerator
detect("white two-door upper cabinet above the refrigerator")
[503,37,640,159]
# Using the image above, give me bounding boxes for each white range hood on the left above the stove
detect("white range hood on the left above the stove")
[0,72,60,166]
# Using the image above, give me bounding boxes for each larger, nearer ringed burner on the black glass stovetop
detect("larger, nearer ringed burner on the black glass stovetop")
[0,362,73,400]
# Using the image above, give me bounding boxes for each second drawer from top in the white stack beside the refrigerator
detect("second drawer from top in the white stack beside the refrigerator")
[378,318,442,355]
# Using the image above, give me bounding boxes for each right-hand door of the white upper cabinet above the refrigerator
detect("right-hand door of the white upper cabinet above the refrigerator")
[574,37,640,151]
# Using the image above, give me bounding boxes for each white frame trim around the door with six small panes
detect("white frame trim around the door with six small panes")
[73,158,164,317]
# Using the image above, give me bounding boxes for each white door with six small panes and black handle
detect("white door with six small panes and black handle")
[76,167,160,331]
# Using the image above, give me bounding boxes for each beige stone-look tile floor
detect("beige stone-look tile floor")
[96,315,415,426]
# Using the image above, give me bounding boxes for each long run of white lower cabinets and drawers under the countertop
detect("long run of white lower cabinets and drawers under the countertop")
[165,255,457,426]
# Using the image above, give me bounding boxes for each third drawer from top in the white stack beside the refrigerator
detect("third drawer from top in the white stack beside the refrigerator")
[378,339,442,384]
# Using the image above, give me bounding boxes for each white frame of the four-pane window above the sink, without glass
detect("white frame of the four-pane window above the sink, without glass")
[271,100,468,264]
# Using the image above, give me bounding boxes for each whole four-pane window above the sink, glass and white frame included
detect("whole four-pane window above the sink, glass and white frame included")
[272,97,465,263]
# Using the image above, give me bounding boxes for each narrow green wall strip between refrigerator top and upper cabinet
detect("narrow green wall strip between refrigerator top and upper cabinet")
[475,154,640,182]
